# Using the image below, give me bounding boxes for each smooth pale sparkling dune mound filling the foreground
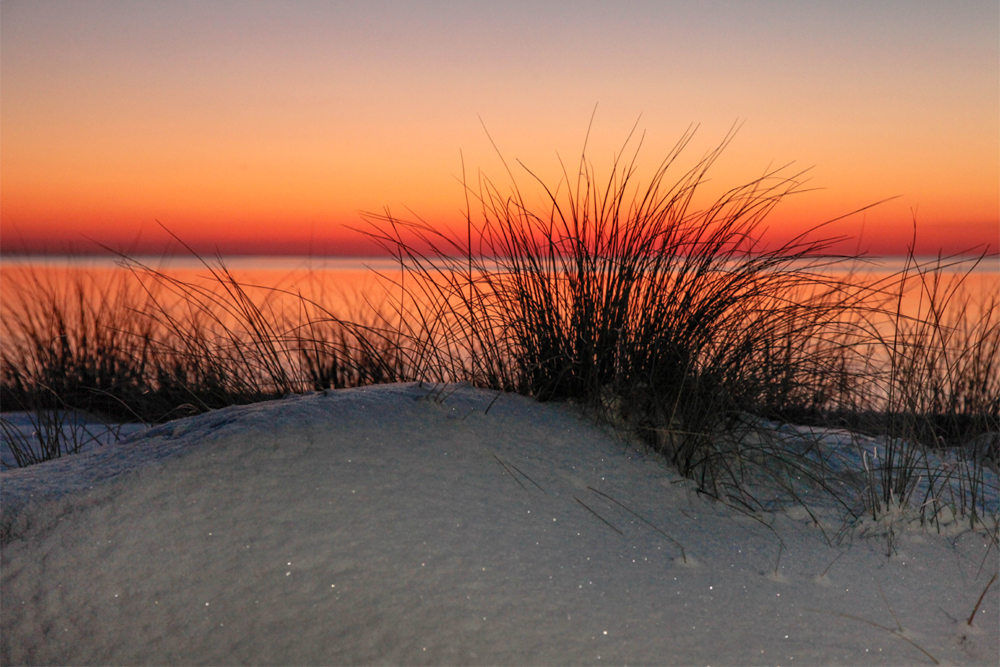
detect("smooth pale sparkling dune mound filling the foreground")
[0,384,1000,665]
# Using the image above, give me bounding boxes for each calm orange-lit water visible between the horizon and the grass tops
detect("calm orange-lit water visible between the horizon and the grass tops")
[0,257,1000,344]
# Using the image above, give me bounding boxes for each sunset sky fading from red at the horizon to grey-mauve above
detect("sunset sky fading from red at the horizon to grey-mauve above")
[0,0,1000,255]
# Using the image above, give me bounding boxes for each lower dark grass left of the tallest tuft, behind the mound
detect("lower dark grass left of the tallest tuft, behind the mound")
[0,250,409,466]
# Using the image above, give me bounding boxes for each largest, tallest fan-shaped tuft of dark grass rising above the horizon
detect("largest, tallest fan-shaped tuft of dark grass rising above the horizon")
[358,124,884,504]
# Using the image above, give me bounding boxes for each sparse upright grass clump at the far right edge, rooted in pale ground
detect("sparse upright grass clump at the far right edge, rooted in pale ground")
[844,246,1000,529]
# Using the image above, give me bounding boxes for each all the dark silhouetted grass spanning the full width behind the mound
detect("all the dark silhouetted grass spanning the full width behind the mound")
[0,133,1000,525]
